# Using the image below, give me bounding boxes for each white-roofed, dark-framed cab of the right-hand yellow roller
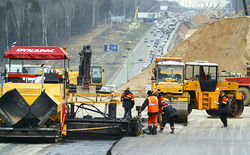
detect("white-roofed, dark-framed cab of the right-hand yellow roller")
[185,61,218,92]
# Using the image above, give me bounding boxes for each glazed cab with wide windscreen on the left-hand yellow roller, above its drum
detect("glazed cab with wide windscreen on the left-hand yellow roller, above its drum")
[155,61,184,83]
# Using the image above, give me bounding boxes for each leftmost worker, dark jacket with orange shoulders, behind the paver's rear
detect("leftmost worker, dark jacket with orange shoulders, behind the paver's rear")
[121,88,135,118]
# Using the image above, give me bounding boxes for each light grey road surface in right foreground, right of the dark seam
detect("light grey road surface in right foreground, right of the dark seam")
[112,107,250,155]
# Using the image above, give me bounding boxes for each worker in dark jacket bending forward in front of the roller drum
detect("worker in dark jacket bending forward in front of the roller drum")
[160,102,177,134]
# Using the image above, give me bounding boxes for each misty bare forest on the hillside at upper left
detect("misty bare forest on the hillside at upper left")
[0,0,156,63]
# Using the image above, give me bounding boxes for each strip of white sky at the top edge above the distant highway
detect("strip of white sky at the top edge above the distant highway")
[169,0,228,7]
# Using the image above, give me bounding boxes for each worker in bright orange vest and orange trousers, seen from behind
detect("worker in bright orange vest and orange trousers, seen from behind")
[142,90,160,135]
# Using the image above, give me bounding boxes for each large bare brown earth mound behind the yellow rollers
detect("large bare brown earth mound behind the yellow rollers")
[120,16,250,96]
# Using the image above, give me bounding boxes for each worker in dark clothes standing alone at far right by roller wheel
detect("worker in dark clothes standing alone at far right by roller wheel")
[219,91,229,128]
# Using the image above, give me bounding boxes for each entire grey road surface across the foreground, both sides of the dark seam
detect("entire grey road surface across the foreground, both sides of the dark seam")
[0,105,250,155]
